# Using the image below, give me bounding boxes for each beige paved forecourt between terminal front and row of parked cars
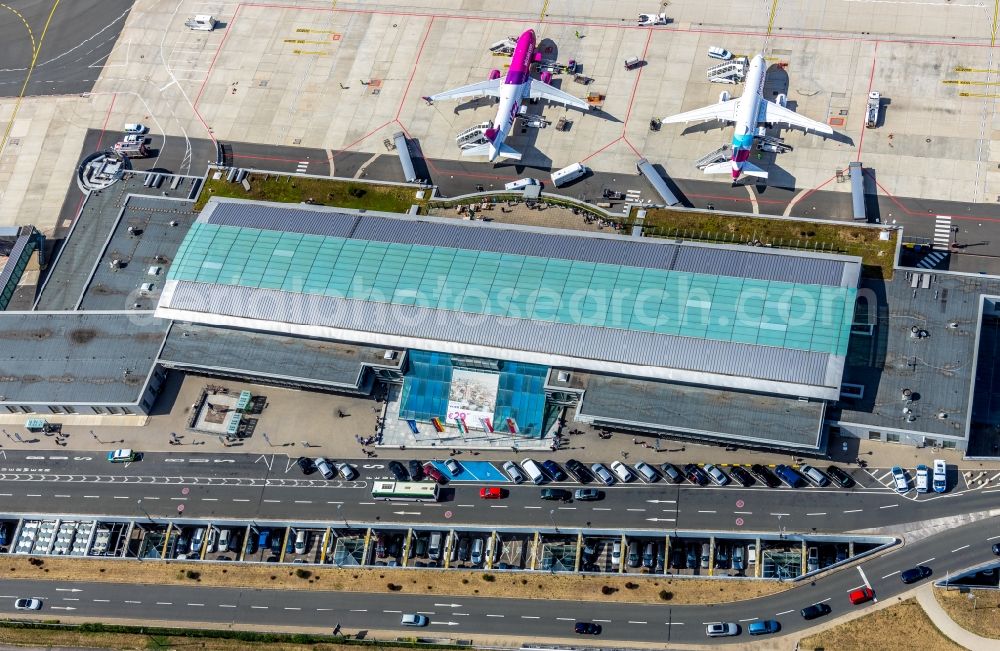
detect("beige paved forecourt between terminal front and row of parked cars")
[0,374,1000,471]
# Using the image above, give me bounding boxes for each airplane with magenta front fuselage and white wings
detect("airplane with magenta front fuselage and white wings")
[427,29,590,162]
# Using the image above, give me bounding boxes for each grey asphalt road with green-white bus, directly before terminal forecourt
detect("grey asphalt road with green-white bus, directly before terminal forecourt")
[0,450,1000,533]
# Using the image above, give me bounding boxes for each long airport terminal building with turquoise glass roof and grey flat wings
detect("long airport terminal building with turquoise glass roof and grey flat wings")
[0,178,1000,456]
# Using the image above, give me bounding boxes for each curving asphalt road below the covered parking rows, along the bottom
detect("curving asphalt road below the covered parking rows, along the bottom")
[0,518,1000,643]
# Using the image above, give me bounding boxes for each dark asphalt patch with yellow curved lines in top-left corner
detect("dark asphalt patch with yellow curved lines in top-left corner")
[0,0,134,97]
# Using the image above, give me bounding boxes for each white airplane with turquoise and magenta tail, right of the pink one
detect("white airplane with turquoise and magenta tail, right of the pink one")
[662,54,833,181]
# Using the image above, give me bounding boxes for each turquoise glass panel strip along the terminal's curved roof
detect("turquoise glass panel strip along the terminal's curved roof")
[168,222,857,355]
